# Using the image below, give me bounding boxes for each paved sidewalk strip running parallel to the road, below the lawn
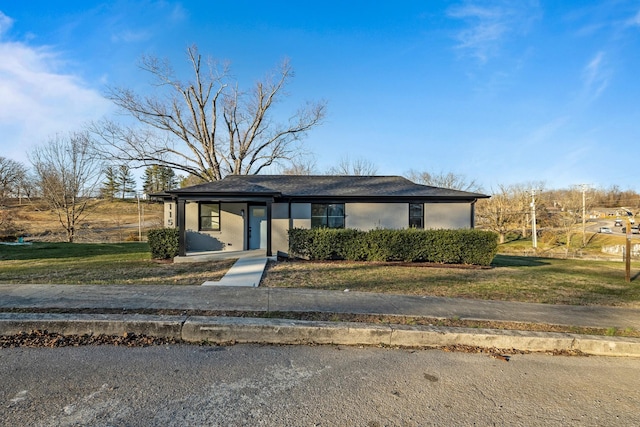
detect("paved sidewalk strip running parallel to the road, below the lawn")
[0,284,640,330]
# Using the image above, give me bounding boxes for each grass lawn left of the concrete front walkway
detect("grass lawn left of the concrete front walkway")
[0,243,235,285]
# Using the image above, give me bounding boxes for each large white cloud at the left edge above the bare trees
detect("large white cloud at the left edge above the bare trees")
[0,38,111,162]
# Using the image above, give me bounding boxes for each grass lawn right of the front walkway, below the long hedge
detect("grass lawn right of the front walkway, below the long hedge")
[261,255,640,307]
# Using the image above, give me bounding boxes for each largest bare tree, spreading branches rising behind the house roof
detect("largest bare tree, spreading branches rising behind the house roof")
[91,46,326,182]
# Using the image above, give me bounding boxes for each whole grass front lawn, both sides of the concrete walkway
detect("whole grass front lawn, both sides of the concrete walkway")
[5,242,640,307]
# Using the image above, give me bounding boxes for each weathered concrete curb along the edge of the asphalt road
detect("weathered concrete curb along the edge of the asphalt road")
[0,313,640,357]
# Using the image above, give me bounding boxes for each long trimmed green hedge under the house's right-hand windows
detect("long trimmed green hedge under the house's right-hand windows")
[289,228,498,265]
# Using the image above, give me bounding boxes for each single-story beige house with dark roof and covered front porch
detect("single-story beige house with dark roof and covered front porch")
[156,175,489,256]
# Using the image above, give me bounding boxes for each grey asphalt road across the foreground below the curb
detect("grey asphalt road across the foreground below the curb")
[0,345,640,427]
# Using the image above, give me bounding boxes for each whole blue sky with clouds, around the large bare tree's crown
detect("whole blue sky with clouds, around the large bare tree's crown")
[0,0,640,192]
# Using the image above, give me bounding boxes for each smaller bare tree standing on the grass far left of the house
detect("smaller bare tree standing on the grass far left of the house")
[29,132,102,243]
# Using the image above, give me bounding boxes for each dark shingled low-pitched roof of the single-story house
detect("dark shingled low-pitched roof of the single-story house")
[167,175,488,200]
